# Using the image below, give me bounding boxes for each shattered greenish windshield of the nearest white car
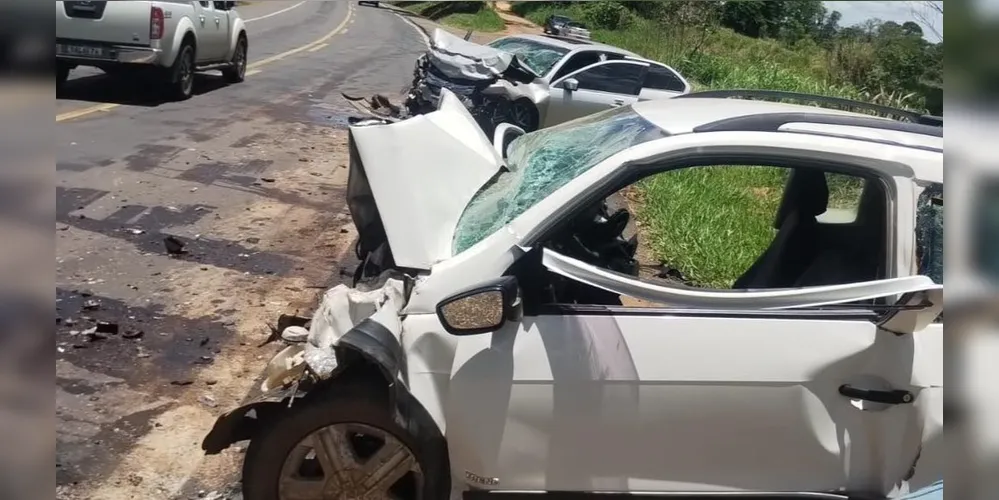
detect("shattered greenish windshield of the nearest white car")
[453,107,665,255]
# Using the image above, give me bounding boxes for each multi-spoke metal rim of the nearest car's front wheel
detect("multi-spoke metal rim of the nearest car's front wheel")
[278,423,423,500]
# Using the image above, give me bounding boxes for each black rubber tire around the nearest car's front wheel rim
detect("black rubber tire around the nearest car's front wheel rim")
[242,387,450,500]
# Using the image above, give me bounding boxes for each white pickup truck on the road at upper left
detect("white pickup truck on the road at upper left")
[56,0,247,100]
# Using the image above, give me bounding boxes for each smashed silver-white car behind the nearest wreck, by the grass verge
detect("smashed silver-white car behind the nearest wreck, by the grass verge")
[352,29,691,135]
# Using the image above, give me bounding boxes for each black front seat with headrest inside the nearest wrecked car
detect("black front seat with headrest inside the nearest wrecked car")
[733,169,829,289]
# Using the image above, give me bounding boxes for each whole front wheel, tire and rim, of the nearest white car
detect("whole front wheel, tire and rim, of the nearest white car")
[243,390,449,500]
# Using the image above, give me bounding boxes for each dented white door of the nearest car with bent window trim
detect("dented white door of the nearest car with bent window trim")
[447,250,943,495]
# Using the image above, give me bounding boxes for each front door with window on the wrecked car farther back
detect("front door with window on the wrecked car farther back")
[545,60,649,127]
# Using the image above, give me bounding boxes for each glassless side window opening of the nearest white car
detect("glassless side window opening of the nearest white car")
[538,165,889,307]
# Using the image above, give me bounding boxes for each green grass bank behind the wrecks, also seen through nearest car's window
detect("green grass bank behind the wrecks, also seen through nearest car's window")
[514,3,872,288]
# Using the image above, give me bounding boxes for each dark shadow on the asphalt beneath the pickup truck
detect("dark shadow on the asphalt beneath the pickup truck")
[56,73,235,108]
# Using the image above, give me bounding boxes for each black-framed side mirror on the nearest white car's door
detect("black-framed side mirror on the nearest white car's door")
[437,276,522,335]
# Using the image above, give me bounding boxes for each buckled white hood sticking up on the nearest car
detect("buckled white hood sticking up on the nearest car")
[347,89,503,270]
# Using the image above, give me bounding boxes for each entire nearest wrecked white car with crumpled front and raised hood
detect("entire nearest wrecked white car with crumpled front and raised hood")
[203,90,944,500]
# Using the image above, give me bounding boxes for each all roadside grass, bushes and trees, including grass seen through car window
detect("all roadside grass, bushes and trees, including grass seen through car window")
[512,0,943,288]
